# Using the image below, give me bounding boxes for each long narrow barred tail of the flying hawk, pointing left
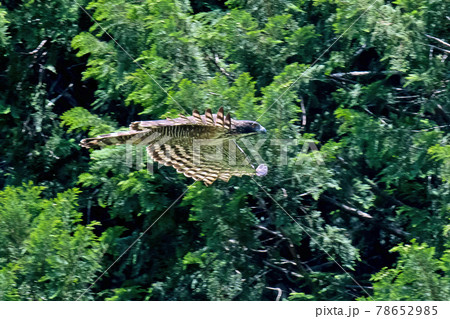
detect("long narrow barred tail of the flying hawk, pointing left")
[80,131,149,149]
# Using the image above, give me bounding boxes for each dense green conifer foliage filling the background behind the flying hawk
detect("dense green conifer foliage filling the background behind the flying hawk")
[0,0,450,300]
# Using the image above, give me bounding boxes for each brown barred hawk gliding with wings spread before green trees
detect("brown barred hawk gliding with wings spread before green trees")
[80,107,267,186]
